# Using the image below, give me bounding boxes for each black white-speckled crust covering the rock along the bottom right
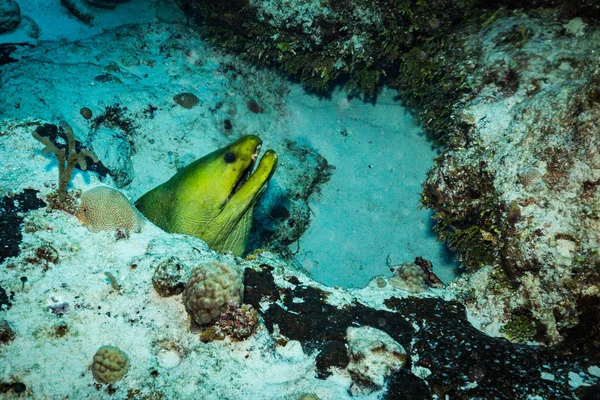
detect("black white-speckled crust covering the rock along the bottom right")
[244,262,600,400]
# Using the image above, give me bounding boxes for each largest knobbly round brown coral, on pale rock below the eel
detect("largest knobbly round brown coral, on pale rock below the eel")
[183,262,244,325]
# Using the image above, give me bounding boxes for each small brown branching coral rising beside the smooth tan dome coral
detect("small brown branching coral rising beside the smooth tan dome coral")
[32,121,98,203]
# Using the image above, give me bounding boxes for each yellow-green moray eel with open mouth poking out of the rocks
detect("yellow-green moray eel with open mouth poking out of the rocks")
[135,136,277,256]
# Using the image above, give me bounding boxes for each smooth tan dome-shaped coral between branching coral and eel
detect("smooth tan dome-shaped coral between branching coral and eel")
[75,186,144,232]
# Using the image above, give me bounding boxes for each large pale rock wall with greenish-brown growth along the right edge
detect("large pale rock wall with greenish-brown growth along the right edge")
[422,10,600,344]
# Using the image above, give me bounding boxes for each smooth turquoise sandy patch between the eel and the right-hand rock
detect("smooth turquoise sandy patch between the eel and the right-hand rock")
[287,88,457,287]
